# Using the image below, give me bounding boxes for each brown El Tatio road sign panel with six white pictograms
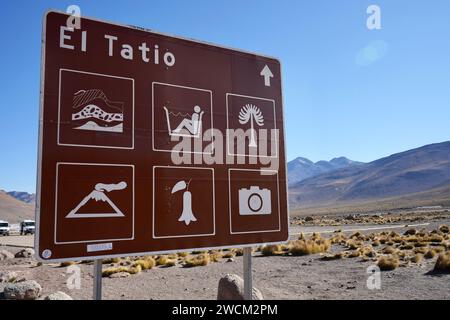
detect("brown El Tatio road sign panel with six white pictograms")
[36,12,288,261]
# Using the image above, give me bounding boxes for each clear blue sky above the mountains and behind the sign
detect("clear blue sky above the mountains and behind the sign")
[0,0,450,192]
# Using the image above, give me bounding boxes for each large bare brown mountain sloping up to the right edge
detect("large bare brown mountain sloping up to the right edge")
[289,141,450,209]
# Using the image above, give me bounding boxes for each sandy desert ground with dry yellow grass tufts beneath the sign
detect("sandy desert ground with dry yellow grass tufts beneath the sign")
[0,210,450,300]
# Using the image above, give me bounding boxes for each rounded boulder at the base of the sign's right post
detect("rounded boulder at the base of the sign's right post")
[217,274,264,300]
